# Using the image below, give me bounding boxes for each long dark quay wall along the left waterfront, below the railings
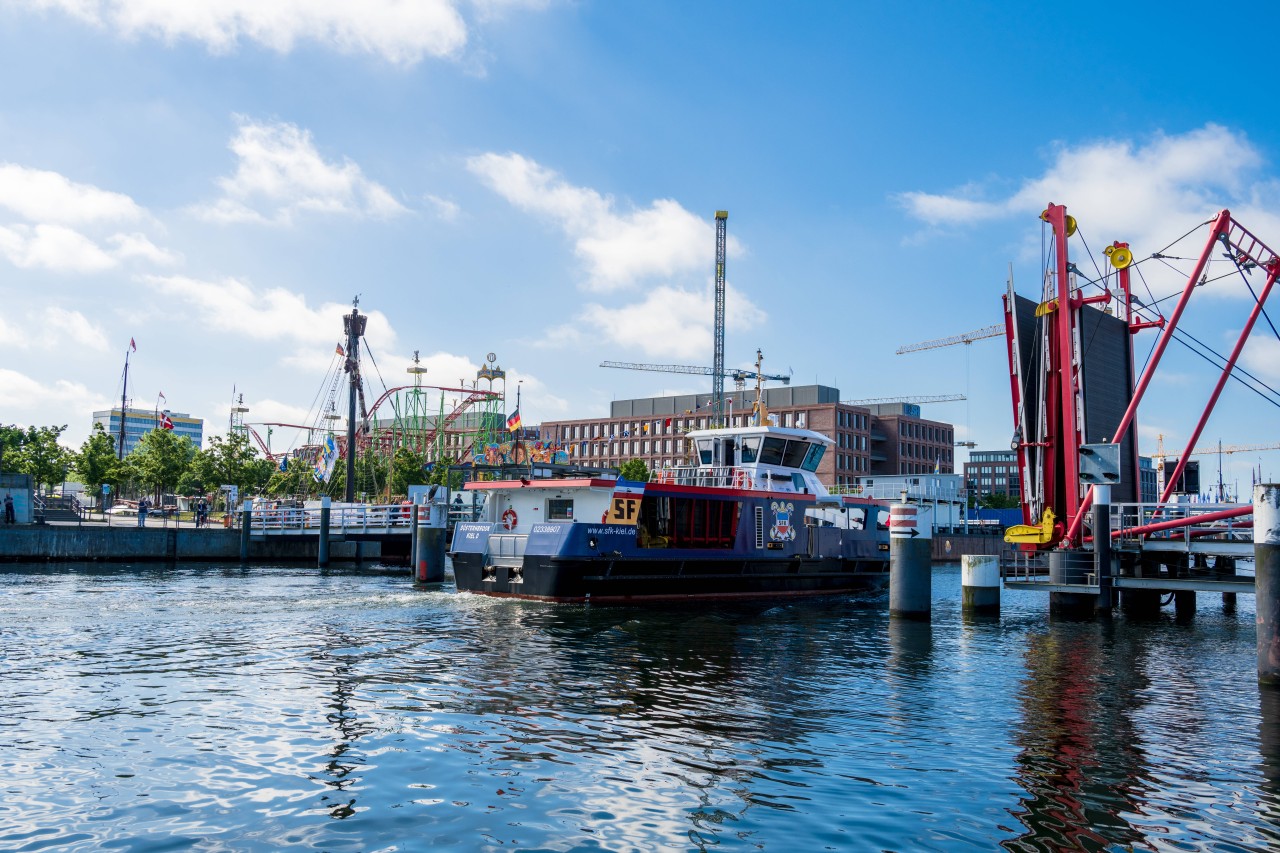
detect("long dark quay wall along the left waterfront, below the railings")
[0,525,381,562]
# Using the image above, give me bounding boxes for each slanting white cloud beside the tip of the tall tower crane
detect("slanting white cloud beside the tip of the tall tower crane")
[467,152,739,291]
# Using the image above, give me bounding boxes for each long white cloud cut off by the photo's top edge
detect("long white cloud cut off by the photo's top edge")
[26,0,471,65]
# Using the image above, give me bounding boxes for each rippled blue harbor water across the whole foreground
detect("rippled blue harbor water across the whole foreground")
[0,565,1280,850]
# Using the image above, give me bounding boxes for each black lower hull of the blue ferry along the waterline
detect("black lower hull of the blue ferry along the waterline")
[453,553,888,605]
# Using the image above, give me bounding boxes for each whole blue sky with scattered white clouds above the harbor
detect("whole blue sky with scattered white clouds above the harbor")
[0,0,1280,494]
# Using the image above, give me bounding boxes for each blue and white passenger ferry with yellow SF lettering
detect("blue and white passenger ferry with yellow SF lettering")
[449,425,888,603]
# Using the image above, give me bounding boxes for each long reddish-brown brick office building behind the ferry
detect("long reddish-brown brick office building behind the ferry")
[540,386,954,485]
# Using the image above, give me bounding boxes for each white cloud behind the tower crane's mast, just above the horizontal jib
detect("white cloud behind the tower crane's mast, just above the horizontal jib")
[540,280,765,356]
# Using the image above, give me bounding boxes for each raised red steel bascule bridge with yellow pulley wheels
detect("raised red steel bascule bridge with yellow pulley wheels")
[1005,204,1280,610]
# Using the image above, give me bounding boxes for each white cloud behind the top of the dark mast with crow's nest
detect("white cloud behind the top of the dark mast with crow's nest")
[142,275,396,350]
